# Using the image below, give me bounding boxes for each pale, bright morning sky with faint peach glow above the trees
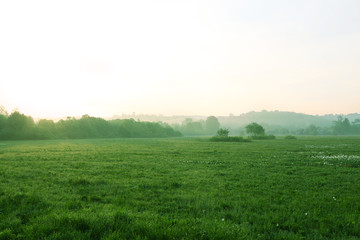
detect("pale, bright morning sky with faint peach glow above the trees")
[0,0,360,118]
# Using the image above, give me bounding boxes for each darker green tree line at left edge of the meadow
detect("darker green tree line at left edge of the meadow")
[0,111,182,140]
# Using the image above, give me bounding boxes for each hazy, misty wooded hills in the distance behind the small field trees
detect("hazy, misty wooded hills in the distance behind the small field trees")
[113,110,360,136]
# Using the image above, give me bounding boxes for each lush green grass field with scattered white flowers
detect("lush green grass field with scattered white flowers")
[0,137,360,239]
